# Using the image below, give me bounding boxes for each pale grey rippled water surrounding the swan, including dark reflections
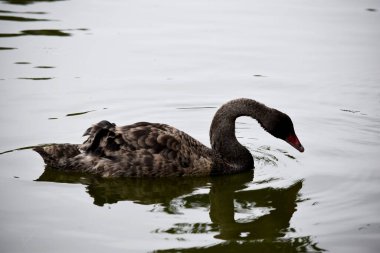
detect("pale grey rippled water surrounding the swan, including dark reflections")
[0,0,380,252]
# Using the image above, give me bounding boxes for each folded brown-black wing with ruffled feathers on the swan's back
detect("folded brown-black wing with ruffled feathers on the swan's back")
[81,121,211,177]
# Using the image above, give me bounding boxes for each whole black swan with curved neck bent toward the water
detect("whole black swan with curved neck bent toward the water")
[34,98,304,177]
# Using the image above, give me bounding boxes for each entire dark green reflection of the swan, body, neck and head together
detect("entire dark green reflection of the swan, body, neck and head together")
[36,167,324,252]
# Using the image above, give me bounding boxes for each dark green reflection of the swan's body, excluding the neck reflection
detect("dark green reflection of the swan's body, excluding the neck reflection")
[36,167,209,206]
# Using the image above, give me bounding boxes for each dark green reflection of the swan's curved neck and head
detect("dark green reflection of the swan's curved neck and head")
[153,180,324,252]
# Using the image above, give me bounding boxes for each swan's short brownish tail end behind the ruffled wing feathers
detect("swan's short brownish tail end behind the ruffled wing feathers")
[33,144,81,169]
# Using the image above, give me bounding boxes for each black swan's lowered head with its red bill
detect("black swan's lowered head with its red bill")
[261,109,305,152]
